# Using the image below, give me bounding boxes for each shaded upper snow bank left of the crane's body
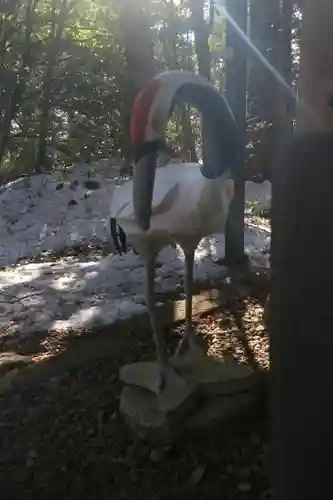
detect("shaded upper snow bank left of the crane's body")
[0,161,124,268]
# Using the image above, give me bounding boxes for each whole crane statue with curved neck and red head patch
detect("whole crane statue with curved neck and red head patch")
[110,71,239,394]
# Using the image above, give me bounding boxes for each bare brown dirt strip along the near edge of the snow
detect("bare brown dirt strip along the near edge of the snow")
[0,271,268,394]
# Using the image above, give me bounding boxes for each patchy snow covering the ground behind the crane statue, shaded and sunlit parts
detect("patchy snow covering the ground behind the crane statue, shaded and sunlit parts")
[0,165,270,338]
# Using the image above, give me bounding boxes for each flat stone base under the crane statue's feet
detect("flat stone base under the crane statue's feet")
[120,352,256,441]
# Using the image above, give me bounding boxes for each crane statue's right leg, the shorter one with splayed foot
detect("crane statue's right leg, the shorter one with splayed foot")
[175,249,204,356]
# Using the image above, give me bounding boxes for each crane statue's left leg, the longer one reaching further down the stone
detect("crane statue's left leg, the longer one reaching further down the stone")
[146,257,172,393]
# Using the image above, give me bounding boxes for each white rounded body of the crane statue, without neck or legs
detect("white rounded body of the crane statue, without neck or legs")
[110,163,234,255]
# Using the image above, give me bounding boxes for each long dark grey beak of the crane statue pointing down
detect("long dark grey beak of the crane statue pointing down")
[133,151,157,231]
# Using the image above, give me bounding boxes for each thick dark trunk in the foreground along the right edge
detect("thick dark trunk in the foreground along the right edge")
[271,0,333,500]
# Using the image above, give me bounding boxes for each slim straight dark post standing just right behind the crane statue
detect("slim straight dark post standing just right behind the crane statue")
[226,0,248,268]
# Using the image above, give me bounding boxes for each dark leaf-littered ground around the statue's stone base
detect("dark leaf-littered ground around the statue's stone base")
[0,292,271,500]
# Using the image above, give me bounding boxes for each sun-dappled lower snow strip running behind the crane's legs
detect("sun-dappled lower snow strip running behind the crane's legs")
[0,228,270,336]
